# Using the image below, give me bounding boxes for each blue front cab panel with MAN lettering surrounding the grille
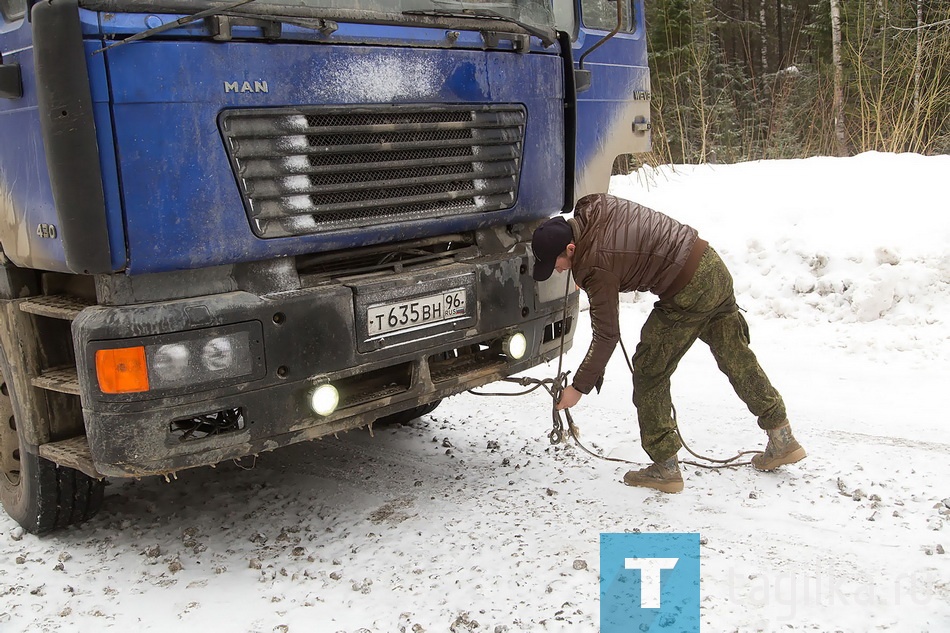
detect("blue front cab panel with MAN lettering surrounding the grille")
[103,16,564,274]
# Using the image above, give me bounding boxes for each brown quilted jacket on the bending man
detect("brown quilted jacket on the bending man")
[568,193,708,393]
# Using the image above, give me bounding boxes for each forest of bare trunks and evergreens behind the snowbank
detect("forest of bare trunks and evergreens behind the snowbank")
[636,0,950,164]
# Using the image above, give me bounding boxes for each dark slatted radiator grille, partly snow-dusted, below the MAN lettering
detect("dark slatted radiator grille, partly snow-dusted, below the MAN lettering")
[219,105,525,238]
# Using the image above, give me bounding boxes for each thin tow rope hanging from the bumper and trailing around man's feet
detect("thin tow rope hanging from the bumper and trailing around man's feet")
[469,275,761,470]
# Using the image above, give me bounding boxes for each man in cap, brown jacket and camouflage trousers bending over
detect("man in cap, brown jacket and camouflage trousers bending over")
[531,194,805,492]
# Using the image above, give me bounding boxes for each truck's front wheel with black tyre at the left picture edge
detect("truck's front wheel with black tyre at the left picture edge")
[0,359,104,534]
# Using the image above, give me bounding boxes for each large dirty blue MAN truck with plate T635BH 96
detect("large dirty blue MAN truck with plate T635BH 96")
[0,0,650,533]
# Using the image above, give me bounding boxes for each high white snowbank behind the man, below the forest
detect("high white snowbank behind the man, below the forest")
[611,153,950,336]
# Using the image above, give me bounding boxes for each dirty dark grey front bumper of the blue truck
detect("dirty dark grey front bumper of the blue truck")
[73,246,578,477]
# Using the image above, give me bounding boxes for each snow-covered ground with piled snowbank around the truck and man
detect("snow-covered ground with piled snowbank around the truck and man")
[0,154,950,633]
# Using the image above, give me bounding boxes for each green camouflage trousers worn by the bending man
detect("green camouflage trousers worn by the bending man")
[633,247,786,461]
